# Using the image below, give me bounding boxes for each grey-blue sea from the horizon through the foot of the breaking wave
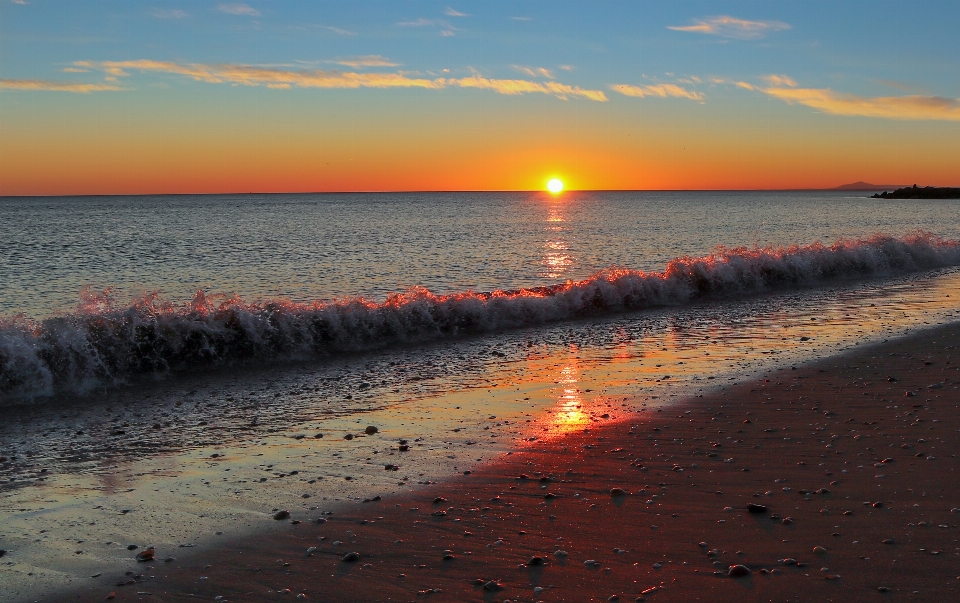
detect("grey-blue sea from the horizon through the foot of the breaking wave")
[0,192,960,400]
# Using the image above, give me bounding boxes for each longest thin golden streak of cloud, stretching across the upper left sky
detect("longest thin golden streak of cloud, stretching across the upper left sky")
[74,59,607,101]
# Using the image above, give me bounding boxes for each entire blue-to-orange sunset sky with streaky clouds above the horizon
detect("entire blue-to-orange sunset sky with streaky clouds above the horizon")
[0,0,960,195]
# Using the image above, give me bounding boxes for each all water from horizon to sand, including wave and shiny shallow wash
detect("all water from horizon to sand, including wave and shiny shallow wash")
[0,191,960,596]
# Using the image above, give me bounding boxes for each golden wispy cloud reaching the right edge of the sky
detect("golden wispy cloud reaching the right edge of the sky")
[752,82,960,121]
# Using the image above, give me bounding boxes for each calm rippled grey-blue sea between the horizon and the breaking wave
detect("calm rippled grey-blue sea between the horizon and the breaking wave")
[0,192,960,319]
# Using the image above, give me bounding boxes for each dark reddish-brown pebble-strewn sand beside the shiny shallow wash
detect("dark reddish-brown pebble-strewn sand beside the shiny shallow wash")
[31,324,960,602]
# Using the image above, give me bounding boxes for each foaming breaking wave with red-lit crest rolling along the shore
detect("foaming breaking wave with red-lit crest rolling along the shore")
[0,232,960,401]
